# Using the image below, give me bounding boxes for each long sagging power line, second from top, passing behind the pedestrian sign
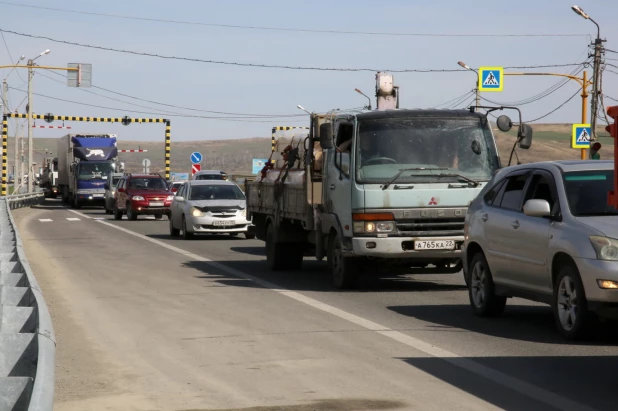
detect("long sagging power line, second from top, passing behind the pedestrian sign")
[0,29,582,73]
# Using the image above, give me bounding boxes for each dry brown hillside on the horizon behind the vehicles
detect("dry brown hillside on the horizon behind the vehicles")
[8,124,613,178]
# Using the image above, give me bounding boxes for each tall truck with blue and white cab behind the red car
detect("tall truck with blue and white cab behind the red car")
[58,134,121,208]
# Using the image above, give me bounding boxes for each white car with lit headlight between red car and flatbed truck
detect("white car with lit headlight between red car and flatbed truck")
[170,180,255,240]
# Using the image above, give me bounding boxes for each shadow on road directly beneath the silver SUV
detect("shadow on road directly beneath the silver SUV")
[388,300,618,345]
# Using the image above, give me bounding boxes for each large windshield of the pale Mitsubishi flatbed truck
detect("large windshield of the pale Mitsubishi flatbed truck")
[356,118,498,183]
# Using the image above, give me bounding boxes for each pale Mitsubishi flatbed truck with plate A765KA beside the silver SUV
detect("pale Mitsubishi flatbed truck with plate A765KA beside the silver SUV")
[246,73,532,289]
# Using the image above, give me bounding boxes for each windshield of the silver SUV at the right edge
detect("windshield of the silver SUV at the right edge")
[563,170,618,217]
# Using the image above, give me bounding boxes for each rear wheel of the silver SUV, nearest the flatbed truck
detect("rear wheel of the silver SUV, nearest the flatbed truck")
[468,253,506,317]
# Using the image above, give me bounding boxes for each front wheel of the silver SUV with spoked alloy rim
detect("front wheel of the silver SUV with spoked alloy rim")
[552,264,590,340]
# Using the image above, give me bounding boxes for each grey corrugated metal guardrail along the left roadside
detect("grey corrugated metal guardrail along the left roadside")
[0,198,56,411]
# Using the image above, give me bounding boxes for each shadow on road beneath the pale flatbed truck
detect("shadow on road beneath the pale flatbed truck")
[183,260,465,293]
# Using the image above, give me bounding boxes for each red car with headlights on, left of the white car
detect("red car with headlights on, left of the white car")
[114,174,174,220]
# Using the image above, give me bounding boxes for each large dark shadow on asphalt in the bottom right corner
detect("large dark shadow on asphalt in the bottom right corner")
[400,356,618,411]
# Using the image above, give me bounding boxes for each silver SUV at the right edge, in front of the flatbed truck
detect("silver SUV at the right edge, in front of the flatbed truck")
[462,160,618,339]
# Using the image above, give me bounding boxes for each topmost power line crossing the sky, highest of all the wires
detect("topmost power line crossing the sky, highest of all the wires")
[0,1,588,37]
